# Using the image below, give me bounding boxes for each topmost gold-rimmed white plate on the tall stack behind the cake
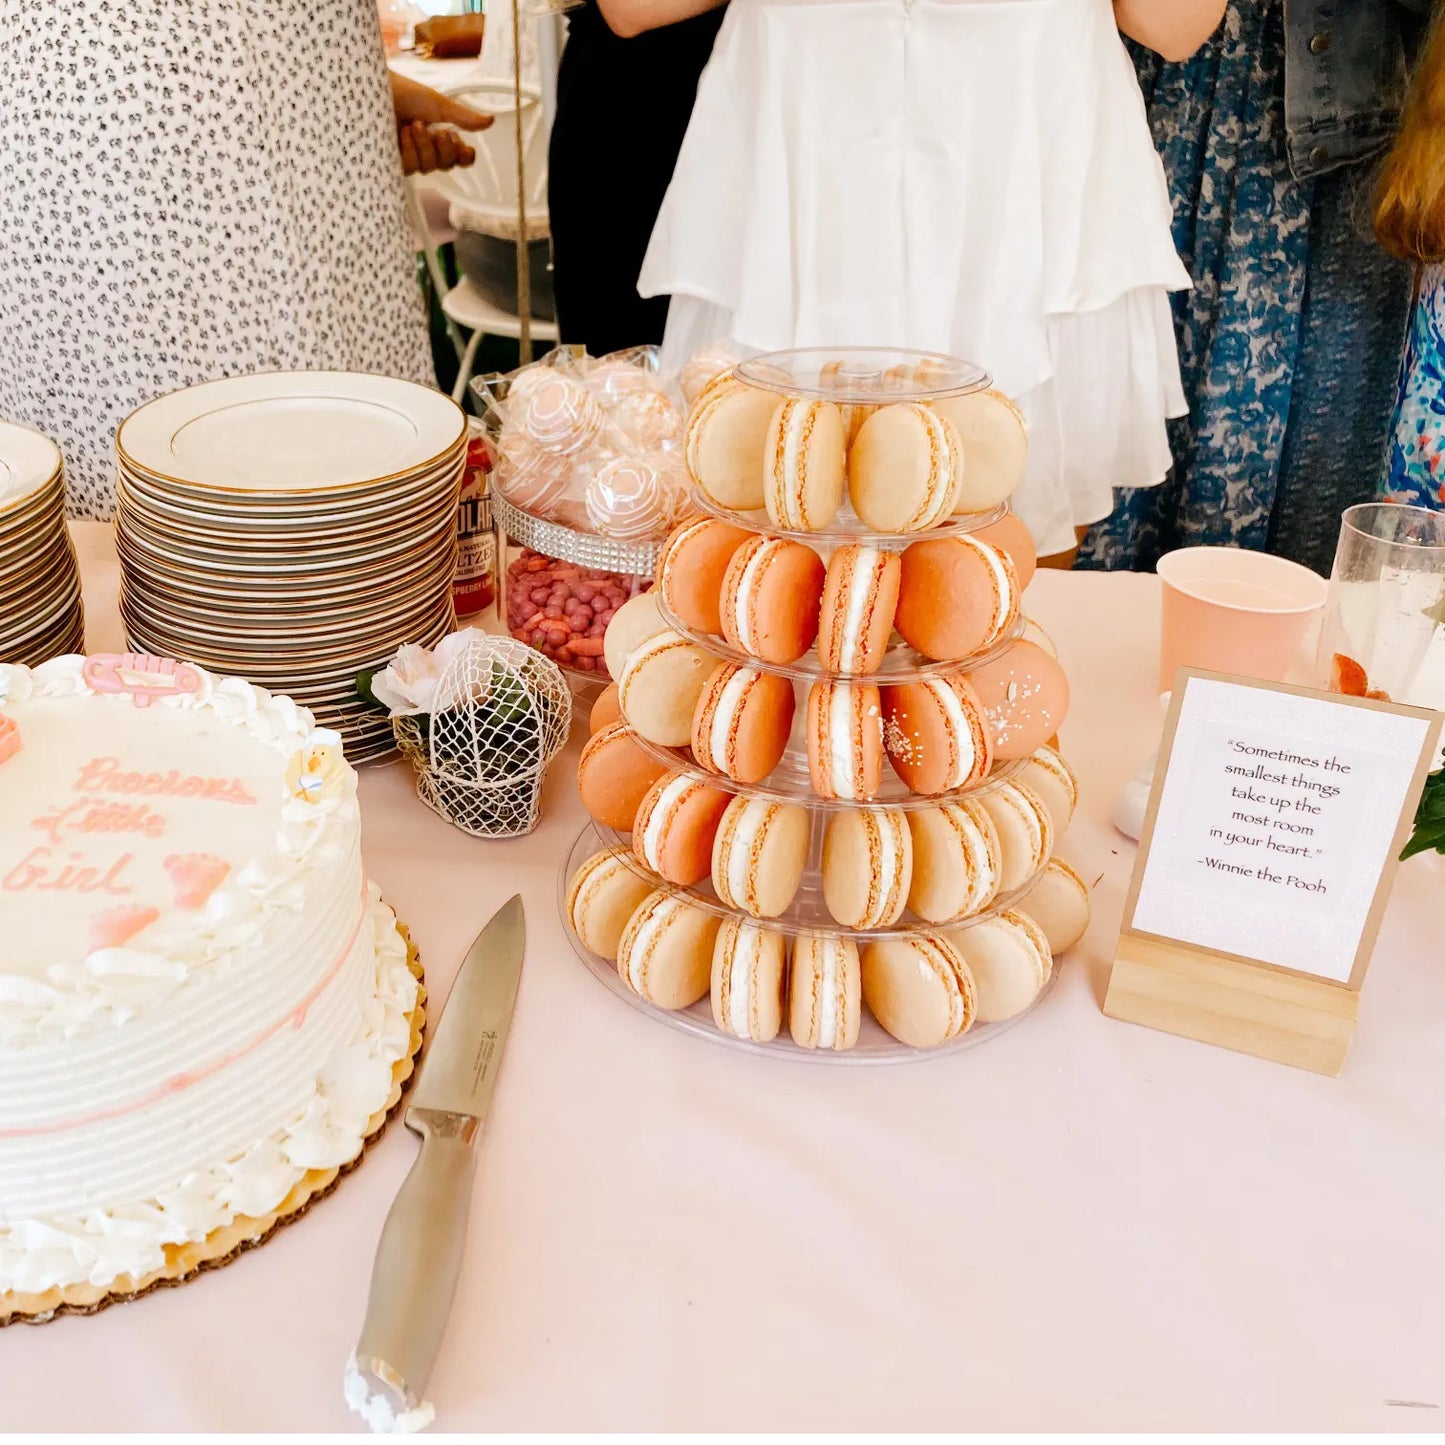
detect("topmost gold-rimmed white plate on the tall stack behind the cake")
[116,371,467,501]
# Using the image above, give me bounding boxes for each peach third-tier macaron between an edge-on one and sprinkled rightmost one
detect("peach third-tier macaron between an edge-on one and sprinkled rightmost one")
[883,672,994,795]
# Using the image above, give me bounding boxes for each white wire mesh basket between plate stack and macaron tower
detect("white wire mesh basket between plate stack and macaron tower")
[392,636,572,838]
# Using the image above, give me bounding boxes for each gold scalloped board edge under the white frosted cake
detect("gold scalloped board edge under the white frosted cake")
[0,919,426,1328]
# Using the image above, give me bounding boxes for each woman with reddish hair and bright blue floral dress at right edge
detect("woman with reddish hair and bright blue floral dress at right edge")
[1374,16,1445,509]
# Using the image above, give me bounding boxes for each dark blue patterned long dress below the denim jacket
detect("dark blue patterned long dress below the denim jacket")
[1079,0,1409,574]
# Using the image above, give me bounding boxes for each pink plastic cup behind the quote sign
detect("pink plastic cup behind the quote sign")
[1157,546,1328,691]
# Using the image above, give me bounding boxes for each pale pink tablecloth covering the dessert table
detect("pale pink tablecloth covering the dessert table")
[14,523,1445,1431]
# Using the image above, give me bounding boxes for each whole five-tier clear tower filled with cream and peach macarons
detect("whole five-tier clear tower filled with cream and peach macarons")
[559,350,1088,1064]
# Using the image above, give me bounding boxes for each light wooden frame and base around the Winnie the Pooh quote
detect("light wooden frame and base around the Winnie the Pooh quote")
[1104,669,1445,1077]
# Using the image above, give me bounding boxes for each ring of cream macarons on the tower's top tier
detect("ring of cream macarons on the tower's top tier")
[683,367,1029,536]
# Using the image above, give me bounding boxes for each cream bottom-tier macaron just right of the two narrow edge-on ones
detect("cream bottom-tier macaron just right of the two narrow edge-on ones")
[858,933,978,1049]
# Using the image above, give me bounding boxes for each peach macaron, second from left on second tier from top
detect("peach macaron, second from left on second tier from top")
[720,536,824,663]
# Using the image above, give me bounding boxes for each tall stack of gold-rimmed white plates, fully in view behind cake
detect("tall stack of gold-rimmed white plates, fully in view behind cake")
[116,371,467,762]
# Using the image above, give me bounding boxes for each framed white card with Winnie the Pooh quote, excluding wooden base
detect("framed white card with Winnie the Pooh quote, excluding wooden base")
[1124,675,1439,987]
